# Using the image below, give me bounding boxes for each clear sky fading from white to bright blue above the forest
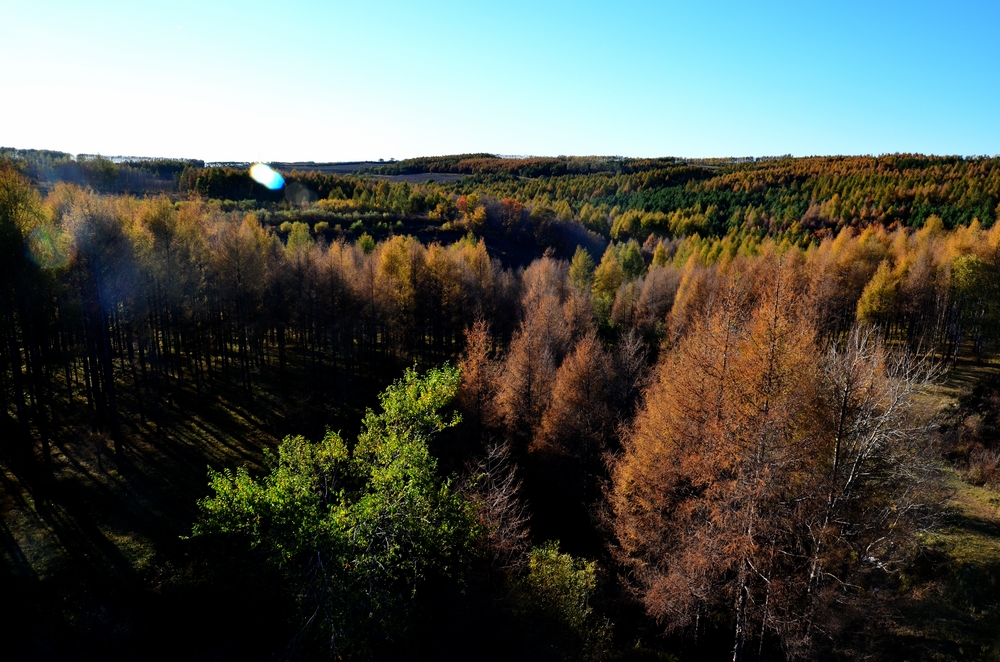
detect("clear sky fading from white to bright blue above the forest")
[0,0,1000,161]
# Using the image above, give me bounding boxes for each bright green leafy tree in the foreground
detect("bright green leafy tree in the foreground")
[195,366,474,655]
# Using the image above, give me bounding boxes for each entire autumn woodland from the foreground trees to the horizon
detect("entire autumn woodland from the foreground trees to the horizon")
[0,149,1000,660]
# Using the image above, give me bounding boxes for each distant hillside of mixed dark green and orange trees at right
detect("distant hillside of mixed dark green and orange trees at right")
[452,155,1000,238]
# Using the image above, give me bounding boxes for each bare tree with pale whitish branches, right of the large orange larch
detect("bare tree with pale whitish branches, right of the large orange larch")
[786,326,938,645]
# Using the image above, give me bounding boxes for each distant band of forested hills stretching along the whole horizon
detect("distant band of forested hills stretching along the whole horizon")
[9,148,1000,241]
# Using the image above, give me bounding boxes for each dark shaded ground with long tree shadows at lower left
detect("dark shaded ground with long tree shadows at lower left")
[0,360,393,659]
